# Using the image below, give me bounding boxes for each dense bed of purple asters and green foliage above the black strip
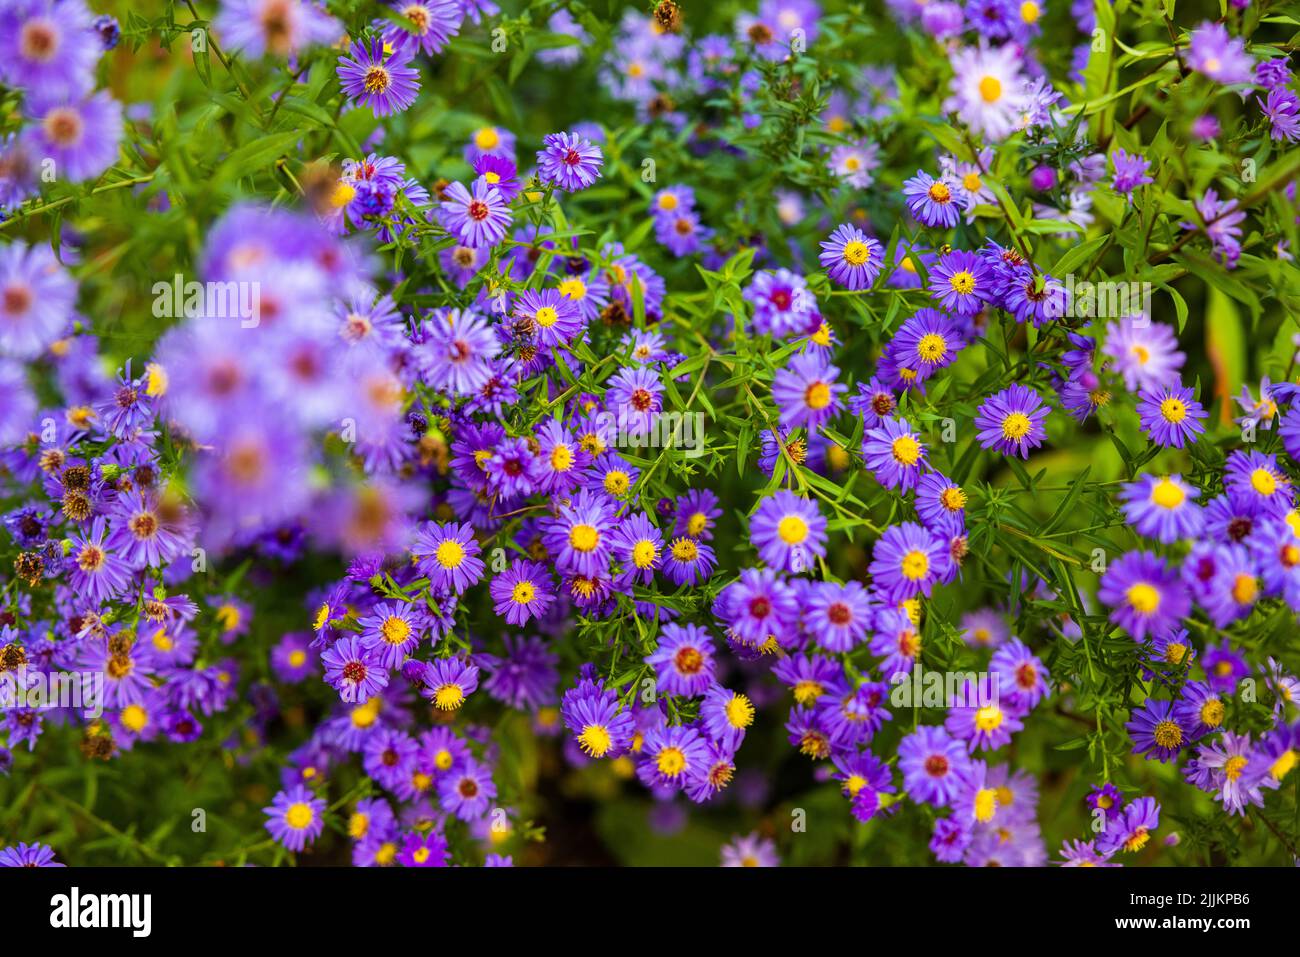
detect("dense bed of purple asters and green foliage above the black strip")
[0,0,1300,866]
